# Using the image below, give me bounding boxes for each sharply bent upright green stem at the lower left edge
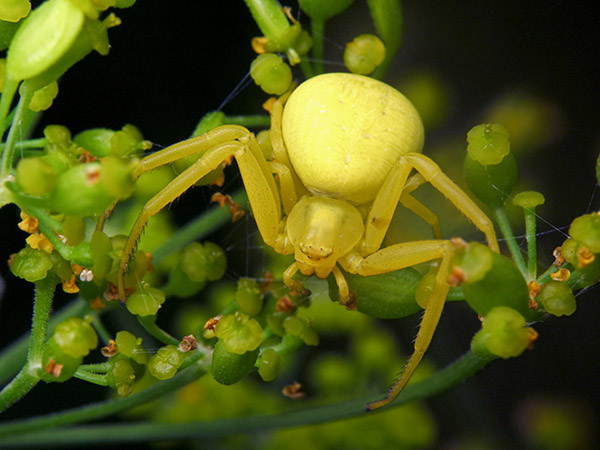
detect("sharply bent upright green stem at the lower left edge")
[0,276,56,412]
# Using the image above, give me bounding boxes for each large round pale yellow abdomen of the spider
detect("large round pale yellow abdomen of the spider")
[282,73,423,204]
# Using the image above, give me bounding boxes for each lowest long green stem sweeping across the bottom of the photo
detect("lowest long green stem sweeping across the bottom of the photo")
[0,352,491,446]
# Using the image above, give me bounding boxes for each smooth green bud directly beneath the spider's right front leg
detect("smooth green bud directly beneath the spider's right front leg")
[327,267,421,319]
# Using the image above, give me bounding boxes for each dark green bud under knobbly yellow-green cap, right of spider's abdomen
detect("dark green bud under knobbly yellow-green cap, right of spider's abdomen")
[464,153,517,206]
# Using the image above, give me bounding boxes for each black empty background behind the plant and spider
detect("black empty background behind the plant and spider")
[0,0,600,445]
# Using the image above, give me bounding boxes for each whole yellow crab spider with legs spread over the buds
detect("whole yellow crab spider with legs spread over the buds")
[119,73,498,409]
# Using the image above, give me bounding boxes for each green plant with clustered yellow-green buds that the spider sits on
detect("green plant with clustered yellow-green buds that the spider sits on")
[0,0,598,450]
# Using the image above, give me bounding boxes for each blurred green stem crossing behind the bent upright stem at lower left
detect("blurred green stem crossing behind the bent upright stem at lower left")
[0,298,90,384]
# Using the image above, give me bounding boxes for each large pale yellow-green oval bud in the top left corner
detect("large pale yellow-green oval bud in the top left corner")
[6,0,84,80]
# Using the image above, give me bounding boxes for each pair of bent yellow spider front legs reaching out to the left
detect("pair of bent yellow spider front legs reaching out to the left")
[118,125,281,299]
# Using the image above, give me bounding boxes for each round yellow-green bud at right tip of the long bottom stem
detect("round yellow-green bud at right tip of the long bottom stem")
[481,306,530,359]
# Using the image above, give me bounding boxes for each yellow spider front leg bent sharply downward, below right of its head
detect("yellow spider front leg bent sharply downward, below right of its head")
[340,240,454,410]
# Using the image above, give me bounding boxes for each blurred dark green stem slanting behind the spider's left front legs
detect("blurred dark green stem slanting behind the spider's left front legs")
[153,189,248,265]
